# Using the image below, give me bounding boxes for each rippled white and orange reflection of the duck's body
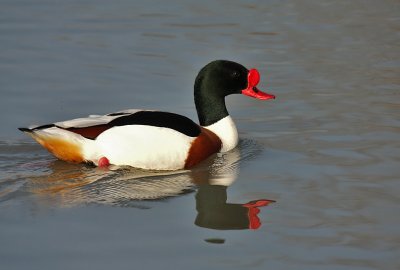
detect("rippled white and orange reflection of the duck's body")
[25,161,194,207]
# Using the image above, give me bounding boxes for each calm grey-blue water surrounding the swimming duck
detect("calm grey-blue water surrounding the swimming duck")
[0,0,400,269]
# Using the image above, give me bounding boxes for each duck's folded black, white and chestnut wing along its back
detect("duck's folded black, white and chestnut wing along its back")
[20,110,201,140]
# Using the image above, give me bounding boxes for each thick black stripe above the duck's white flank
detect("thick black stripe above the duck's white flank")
[108,111,201,137]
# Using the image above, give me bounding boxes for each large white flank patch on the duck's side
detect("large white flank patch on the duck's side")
[95,125,195,170]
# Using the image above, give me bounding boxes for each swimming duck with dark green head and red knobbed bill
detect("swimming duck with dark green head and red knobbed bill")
[19,60,275,170]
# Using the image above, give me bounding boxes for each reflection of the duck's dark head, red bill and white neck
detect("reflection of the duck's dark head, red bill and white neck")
[195,144,275,230]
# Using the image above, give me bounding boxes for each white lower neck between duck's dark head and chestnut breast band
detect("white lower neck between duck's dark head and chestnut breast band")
[204,115,239,152]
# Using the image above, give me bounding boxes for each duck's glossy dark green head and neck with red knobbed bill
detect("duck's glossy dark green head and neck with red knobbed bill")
[194,60,275,126]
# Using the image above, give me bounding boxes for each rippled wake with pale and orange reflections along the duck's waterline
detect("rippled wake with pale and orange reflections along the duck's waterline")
[0,139,262,207]
